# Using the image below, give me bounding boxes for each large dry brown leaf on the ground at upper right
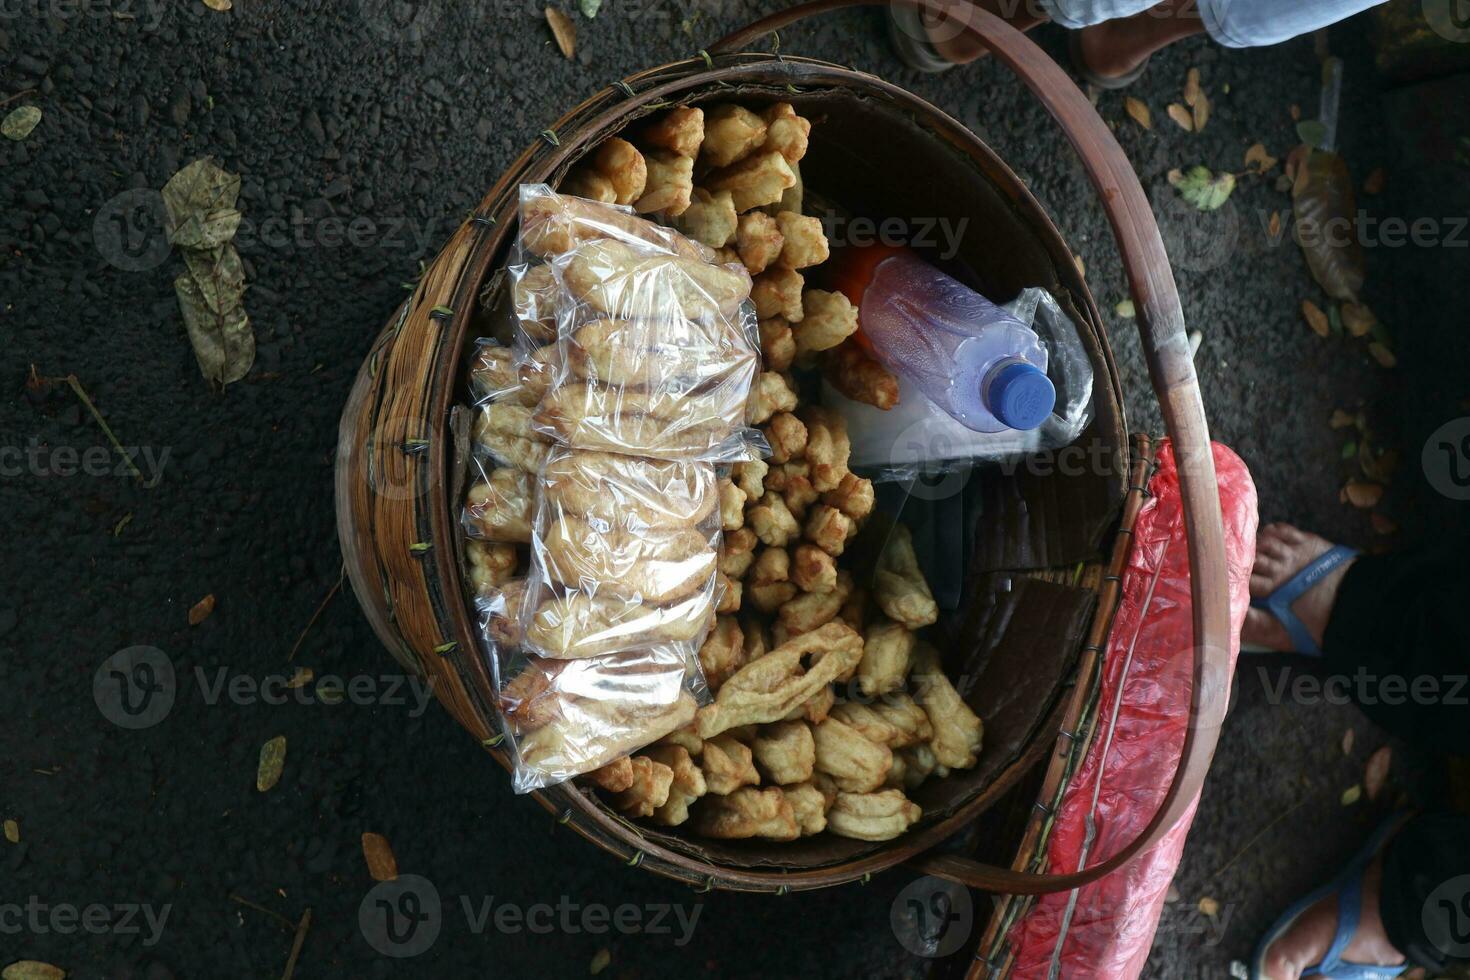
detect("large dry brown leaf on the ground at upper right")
[1292,150,1364,303]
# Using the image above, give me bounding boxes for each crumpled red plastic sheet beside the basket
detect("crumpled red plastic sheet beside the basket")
[1010,441,1257,980]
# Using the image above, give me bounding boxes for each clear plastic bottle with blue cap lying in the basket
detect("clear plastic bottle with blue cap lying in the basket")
[842,248,1057,432]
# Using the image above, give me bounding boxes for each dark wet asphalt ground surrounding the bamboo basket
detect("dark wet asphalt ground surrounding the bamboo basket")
[0,0,1470,980]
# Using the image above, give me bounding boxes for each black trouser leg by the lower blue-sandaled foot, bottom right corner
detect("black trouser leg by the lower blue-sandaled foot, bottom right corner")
[1379,814,1470,976]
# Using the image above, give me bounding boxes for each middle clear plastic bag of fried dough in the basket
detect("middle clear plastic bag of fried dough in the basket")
[520,445,720,660]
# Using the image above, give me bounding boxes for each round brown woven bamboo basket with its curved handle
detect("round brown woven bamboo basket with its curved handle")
[337,0,1227,893]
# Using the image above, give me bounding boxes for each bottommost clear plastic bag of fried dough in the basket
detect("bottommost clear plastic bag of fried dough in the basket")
[478,583,709,793]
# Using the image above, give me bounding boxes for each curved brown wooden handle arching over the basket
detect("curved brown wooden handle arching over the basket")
[710,0,1230,895]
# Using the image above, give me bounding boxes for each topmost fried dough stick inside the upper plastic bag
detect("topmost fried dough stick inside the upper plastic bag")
[520,185,714,263]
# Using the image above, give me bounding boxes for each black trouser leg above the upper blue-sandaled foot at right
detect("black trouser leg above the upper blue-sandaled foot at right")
[1322,538,1470,758]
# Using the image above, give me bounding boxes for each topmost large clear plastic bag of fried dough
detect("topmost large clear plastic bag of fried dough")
[520,185,760,460]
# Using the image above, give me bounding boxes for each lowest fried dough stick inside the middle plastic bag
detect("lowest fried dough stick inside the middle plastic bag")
[520,592,714,660]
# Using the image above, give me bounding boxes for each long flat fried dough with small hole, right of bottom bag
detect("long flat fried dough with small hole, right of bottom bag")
[697,623,858,734]
